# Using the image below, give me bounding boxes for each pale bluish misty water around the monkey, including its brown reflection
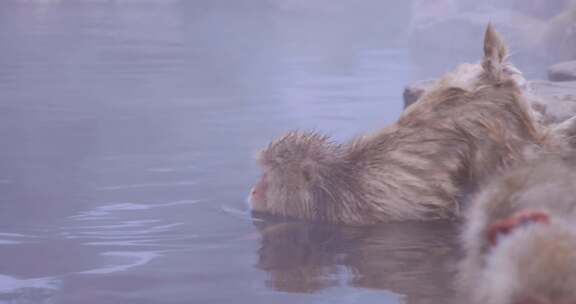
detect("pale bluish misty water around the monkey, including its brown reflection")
[0,0,552,304]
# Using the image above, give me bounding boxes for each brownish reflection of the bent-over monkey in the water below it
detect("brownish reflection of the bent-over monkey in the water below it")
[254,217,457,303]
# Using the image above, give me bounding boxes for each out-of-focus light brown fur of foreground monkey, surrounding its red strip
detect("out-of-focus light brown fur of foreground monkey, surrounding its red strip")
[458,156,576,304]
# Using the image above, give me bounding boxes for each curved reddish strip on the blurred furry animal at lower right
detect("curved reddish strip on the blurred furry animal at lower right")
[487,209,550,245]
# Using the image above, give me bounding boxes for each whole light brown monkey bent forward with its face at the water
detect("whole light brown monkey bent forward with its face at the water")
[250,26,552,225]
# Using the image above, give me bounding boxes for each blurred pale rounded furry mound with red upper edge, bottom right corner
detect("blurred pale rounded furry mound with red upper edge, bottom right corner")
[476,214,576,304]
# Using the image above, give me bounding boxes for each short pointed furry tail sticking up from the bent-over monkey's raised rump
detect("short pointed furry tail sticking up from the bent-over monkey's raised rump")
[482,23,508,82]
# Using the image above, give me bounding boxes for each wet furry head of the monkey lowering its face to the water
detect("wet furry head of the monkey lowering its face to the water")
[249,132,348,220]
